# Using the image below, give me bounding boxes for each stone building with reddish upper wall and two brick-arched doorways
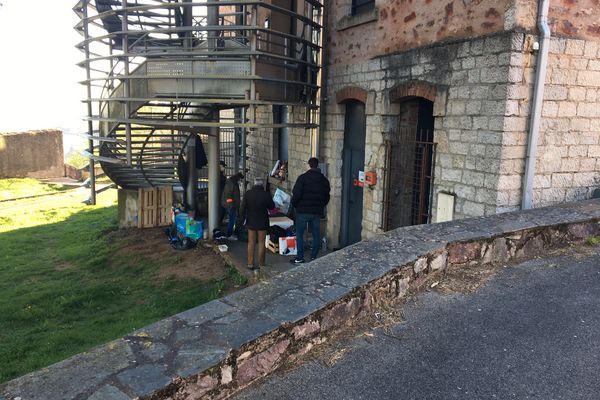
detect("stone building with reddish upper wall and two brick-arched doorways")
[248,0,600,247]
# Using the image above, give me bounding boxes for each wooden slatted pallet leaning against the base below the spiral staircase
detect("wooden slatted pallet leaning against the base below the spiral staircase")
[138,186,173,228]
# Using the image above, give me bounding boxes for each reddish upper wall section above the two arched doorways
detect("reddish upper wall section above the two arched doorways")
[325,0,514,64]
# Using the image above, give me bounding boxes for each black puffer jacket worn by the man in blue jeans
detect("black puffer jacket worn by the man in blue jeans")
[292,168,330,215]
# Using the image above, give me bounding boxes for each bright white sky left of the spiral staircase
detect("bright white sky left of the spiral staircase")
[0,0,87,149]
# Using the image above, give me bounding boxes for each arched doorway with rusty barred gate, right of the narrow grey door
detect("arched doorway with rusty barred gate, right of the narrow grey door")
[385,97,435,230]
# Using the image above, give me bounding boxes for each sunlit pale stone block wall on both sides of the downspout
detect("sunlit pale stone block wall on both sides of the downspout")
[498,38,600,211]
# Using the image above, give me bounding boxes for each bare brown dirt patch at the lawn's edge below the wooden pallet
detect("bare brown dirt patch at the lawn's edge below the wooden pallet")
[110,228,227,282]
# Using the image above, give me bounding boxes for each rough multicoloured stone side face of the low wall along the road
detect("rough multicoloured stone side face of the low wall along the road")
[158,203,600,400]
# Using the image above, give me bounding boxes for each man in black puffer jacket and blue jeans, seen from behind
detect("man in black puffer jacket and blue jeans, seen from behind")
[290,157,330,264]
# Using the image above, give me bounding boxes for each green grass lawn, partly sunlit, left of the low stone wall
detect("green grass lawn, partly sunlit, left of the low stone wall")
[0,179,245,382]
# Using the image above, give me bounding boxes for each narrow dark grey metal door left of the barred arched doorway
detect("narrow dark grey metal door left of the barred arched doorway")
[340,101,366,246]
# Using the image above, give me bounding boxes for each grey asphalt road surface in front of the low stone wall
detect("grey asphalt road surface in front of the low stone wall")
[234,246,600,400]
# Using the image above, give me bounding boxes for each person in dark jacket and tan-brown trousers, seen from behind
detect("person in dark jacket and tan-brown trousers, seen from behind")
[240,178,275,270]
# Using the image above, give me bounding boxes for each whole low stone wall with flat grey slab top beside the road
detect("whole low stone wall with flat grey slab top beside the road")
[0,200,600,399]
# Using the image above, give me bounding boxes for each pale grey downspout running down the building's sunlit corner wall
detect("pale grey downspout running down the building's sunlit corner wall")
[521,0,550,210]
